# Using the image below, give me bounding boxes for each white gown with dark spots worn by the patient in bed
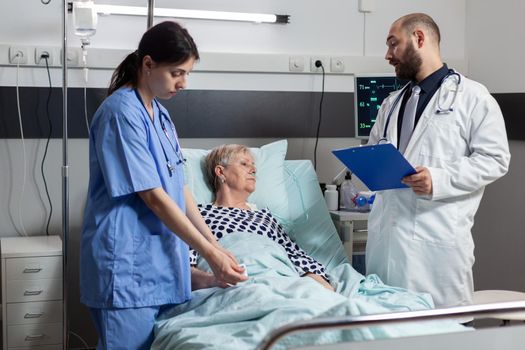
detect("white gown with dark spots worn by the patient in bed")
[190,204,329,281]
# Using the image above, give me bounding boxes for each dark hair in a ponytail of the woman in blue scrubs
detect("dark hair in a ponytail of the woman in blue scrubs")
[108,21,199,95]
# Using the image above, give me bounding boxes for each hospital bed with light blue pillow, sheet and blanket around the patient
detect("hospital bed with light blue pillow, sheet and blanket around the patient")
[152,141,520,350]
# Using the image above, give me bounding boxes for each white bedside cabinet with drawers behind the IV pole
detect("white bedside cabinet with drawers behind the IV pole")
[0,236,63,350]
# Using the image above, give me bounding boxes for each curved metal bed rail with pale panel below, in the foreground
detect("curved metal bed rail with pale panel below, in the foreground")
[257,300,525,350]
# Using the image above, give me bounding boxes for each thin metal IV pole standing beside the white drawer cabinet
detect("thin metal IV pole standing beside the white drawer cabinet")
[62,0,69,350]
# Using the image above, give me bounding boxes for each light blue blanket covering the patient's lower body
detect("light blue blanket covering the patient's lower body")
[152,233,465,350]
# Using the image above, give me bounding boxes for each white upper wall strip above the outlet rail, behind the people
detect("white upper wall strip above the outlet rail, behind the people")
[0,0,465,58]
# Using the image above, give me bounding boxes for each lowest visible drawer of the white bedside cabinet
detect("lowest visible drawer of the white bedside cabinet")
[7,323,62,347]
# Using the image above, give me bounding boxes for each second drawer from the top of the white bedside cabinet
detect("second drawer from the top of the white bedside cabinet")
[5,279,62,303]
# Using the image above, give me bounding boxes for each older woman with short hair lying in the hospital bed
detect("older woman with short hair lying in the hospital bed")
[190,144,334,290]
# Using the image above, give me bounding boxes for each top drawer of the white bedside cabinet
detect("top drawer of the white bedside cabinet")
[5,256,62,281]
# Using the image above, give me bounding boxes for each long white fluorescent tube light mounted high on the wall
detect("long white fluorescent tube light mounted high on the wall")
[95,5,290,23]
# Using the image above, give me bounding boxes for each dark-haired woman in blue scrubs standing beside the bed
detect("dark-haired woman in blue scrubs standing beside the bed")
[80,22,246,349]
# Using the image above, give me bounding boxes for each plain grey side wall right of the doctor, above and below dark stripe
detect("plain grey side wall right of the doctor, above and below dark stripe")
[466,0,525,291]
